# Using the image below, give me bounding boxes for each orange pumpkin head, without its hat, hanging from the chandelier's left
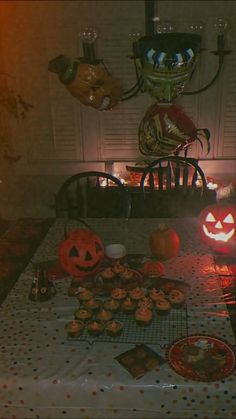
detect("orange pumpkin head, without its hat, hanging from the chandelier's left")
[66,63,123,111]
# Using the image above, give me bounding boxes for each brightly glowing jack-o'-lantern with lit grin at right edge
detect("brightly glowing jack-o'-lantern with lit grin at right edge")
[199,203,236,254]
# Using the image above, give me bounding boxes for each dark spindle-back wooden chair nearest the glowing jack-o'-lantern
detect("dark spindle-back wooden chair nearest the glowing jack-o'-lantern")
[140,156,216,217]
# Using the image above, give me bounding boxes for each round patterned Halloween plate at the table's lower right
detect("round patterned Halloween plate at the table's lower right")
[167,335,235,382]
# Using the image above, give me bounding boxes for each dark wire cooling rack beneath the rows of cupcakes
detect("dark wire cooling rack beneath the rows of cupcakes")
[68,306,188,348]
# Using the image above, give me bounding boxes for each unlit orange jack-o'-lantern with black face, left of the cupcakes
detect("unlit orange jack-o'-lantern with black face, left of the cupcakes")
[58,229,104,278]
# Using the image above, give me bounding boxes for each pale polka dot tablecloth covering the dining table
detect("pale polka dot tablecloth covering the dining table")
[0,219,236,419]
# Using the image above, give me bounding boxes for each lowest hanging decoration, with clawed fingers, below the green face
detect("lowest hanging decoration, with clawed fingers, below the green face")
[139,104,210,156]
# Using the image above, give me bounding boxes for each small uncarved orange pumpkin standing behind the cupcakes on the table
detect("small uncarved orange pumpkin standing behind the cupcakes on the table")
[149,224,180,261]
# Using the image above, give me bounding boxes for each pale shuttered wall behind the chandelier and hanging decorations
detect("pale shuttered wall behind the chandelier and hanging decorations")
[0,0,236,217]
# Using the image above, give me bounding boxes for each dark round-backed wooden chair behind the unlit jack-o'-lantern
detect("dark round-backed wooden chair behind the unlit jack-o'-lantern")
[55,171,131,219]
